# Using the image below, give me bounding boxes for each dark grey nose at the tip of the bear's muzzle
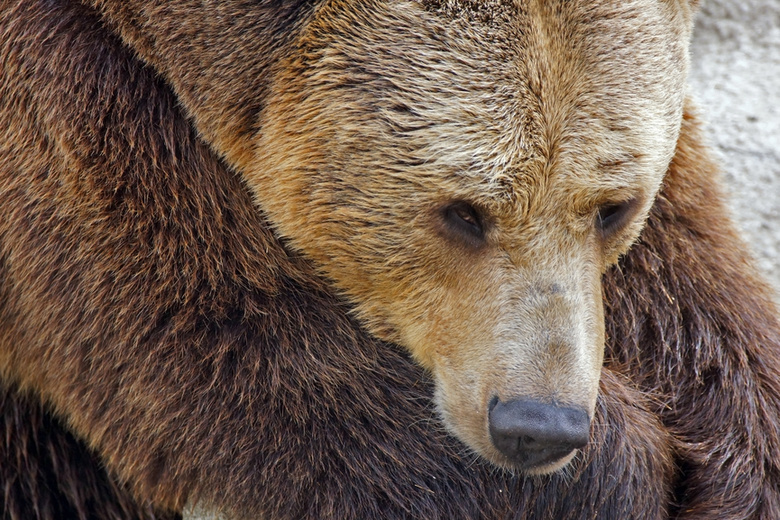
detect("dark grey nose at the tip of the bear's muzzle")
[488,398,590,469]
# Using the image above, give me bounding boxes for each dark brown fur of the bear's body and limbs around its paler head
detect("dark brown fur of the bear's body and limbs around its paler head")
[0,2,780,518]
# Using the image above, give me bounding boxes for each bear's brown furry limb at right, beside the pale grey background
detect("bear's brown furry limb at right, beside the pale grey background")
[604,109,780,519]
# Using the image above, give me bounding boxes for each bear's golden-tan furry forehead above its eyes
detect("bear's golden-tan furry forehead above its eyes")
[284,1,686,200]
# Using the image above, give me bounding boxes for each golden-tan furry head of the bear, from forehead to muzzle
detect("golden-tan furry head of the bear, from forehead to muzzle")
[247,0,690,473]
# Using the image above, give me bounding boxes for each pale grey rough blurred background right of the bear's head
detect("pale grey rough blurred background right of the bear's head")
[690,0,780,302]
